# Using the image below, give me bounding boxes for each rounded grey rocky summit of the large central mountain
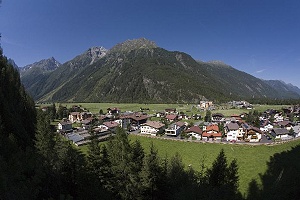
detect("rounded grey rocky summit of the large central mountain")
[110,38,157,52]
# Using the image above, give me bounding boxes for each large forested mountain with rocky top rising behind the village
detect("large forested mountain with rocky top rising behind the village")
[21,38,300,103]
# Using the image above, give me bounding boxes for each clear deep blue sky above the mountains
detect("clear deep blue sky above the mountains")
[0,0,300,87]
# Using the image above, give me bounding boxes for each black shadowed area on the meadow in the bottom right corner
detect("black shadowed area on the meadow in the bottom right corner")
[247,145,300,200]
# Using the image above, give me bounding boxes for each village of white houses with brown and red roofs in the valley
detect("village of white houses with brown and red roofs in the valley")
[57,101,300,146]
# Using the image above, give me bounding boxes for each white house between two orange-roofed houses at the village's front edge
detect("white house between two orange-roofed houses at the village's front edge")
[225,122,244,141]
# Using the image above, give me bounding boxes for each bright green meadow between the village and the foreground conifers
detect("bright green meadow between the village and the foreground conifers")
[80,135,300,197]
